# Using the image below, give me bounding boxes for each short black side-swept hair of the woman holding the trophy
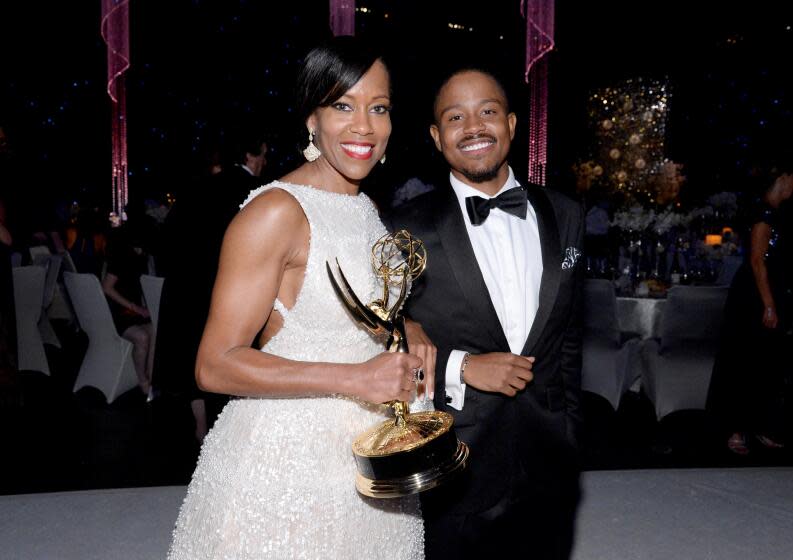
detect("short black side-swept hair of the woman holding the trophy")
[295,36,382,145]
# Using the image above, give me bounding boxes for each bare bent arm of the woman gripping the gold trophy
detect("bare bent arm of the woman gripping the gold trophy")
[196,189,421,403]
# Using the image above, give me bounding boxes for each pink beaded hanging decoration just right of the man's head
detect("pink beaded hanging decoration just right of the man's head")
[520,0,554,185]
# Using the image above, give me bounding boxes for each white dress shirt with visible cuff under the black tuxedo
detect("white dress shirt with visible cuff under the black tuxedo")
[446,168,542,410]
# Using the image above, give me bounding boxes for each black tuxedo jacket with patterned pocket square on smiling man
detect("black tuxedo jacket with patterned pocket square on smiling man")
[386,180,584,517]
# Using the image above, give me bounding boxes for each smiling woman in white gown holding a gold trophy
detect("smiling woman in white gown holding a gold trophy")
[170,37,432,560]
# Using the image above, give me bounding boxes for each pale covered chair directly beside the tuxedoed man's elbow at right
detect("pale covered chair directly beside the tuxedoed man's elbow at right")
[581,279,641,410]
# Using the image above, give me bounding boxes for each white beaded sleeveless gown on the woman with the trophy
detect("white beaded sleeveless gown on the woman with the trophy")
[168,181,424,560]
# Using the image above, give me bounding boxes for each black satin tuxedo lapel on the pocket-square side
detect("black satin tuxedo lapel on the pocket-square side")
[522,184,562,356]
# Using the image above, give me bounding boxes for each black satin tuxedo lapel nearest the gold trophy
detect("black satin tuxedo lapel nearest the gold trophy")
[429,190,509,351]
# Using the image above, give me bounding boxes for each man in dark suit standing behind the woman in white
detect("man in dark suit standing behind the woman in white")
[154,131,267,443]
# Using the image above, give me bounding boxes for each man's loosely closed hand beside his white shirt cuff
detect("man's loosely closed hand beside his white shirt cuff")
[464,352,534,397]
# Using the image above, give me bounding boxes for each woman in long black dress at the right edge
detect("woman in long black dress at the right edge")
[708,168,793,455]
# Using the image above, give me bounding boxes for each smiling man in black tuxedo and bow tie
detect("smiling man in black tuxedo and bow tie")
[391,70,584,560]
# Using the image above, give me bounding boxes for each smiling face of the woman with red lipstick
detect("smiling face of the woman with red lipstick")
[306,60,391,183]
